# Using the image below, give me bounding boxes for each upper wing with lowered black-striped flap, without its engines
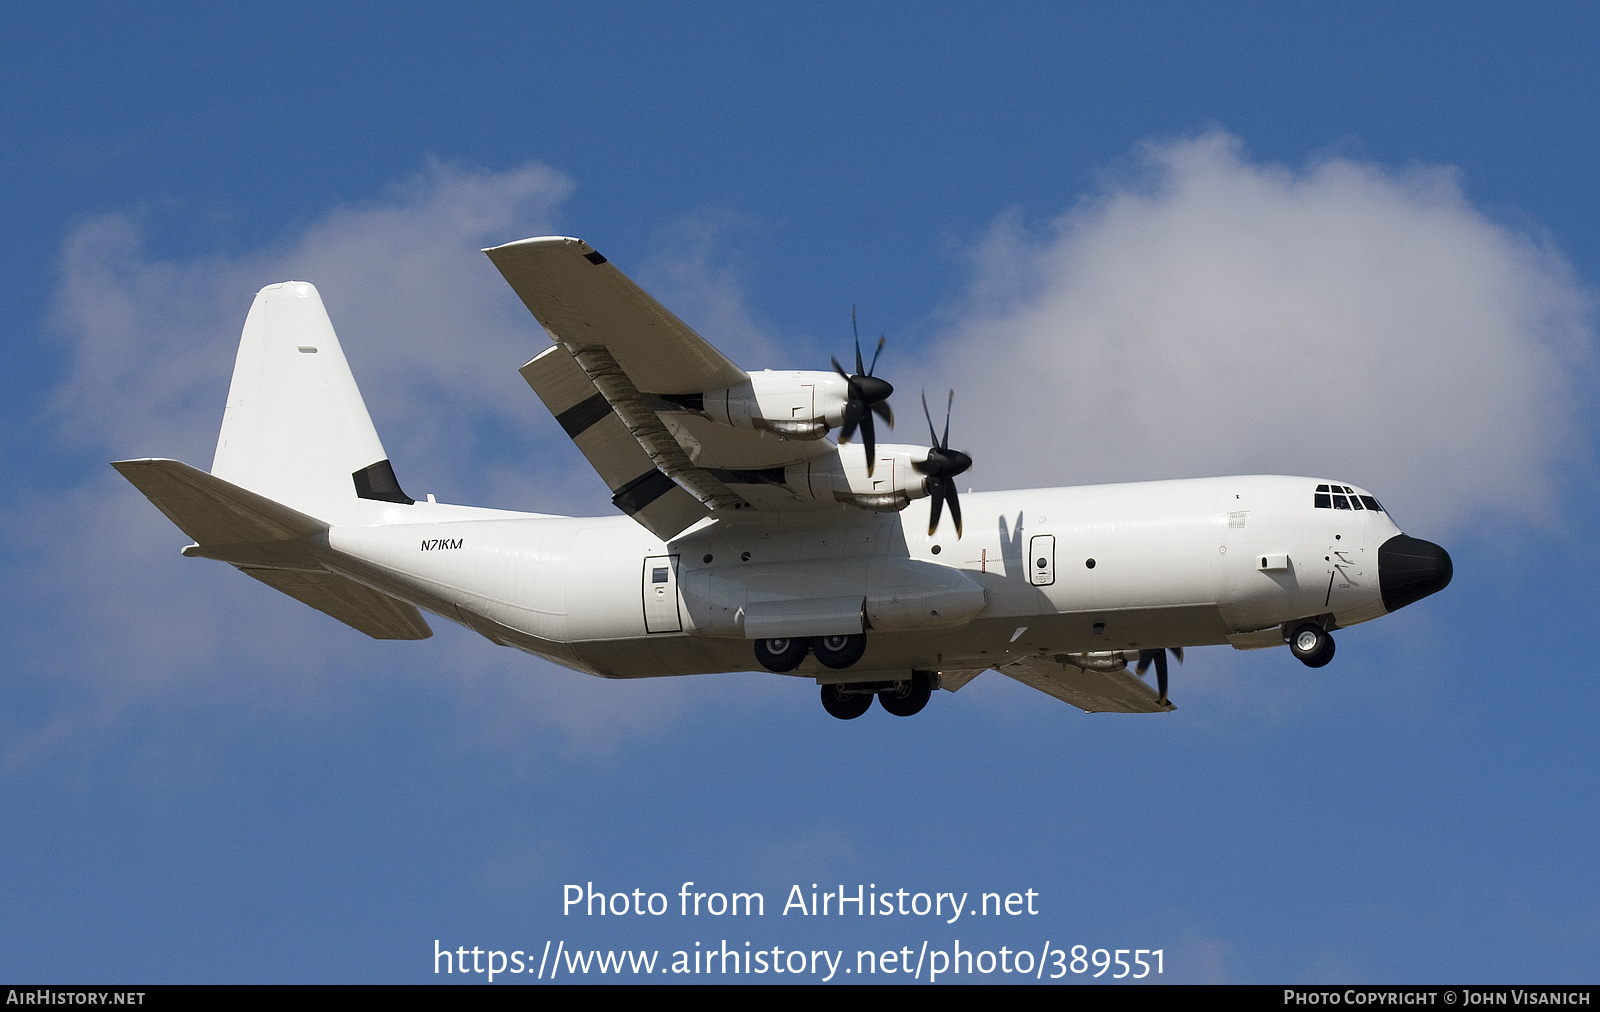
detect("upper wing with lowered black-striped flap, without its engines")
[485,235,834,540]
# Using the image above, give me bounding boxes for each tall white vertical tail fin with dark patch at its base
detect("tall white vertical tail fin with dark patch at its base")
[211,282,411,522]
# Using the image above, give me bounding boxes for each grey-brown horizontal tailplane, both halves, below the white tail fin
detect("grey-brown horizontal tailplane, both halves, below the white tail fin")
[112,460,434,639]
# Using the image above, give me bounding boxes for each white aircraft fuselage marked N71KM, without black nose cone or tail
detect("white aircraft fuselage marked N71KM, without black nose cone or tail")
[312,476,1400,677]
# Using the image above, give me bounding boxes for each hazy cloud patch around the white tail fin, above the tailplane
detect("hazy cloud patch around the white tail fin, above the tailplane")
[53,162,588,506]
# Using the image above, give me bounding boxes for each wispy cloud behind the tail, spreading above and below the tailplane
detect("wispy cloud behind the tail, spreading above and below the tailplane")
[0,162,729,775]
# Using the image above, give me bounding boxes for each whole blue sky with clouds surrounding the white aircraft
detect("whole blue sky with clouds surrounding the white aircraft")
[0,3,1600,983]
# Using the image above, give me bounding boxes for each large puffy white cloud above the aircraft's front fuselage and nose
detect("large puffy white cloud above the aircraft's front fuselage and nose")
[925,131,1594,536]
